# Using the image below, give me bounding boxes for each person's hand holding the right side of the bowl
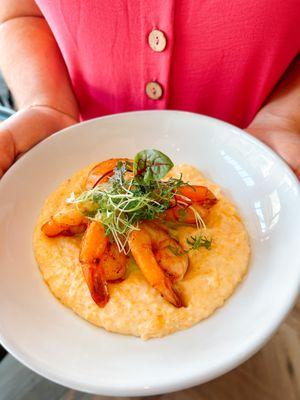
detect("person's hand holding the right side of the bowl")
[246,114,300,179]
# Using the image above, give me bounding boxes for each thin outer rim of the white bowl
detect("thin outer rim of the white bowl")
[0,110,300,396]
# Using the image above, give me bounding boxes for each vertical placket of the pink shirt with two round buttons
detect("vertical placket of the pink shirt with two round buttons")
[140,0,175,109]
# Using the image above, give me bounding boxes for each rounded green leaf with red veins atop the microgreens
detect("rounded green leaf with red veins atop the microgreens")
[133,149,174,183]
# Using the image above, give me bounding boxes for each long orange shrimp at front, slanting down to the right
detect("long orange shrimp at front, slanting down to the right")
[129,223,183,307]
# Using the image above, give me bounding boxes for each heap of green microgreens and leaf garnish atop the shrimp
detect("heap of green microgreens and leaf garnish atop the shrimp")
[67,149,209,251]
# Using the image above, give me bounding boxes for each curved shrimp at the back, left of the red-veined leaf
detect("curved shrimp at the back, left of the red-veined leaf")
[85,158,131,190]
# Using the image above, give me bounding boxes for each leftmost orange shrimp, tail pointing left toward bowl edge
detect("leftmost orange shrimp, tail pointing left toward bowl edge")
[41,208,88,237]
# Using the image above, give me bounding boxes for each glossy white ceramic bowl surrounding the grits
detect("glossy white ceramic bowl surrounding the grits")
[0,111,300,396]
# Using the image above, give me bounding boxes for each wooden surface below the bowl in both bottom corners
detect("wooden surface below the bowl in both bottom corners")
[0,299,300,400]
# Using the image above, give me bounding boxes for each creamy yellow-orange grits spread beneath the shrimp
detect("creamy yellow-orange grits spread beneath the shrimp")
[33,164,250,339]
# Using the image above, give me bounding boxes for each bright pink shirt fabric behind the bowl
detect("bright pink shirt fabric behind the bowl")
[37,0,300,127]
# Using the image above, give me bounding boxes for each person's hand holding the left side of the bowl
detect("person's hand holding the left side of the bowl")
[0,106,77,177]
